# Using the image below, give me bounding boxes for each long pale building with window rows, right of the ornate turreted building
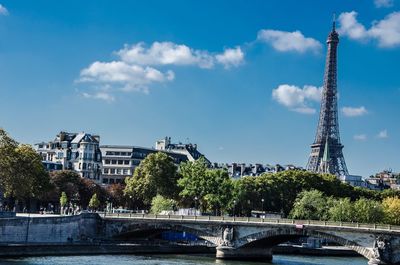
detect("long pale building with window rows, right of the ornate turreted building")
[100,137,208,184]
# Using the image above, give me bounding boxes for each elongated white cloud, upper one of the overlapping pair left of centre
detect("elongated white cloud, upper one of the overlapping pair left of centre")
[116,41,214,68]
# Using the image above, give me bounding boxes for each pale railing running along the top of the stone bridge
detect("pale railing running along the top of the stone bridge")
[100,212,400,233]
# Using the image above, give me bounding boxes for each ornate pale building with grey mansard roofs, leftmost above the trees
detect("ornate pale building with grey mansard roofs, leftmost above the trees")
[34,132,102,183]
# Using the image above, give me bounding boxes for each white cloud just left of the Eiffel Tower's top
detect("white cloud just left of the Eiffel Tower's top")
[257,29,322,53]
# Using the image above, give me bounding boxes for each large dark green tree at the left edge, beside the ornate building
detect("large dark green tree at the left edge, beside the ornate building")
[0,129,50,200]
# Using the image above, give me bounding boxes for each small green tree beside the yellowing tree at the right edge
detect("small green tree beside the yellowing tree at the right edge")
[354,198,384,223]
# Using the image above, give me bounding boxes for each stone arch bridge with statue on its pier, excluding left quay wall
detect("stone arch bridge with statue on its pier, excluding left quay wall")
[102,214,400,265]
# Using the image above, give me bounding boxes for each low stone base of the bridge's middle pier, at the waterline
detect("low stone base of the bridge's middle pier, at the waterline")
[216,246,272,262]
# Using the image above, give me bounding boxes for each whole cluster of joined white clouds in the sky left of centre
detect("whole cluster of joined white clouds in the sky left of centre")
[77,42,244,101]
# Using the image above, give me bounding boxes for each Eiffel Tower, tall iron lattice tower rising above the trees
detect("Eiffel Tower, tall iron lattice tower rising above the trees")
[307,20,349,177]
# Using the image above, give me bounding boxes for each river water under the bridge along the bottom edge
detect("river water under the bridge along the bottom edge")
[0,255,368,265]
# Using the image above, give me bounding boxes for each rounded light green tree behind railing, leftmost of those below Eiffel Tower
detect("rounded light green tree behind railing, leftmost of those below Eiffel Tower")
[289,190,331,220]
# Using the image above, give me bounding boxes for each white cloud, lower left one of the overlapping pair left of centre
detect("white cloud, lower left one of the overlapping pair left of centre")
[78,61,174,92]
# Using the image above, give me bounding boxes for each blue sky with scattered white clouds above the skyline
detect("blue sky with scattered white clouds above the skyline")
[0,0,400,176]
